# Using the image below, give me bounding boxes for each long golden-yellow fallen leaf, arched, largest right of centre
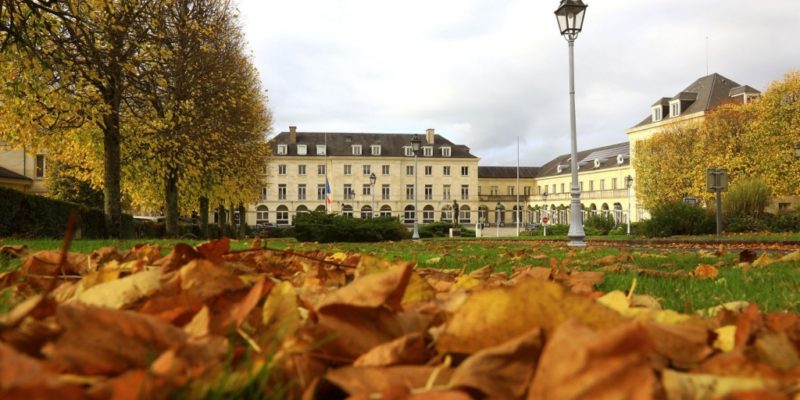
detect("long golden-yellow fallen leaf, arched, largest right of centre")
[437,279,624,353]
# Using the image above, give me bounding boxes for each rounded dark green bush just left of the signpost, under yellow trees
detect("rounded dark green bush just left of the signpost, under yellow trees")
[642,201,716,237]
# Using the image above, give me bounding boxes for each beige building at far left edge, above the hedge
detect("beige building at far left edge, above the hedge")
[0,142,47,195]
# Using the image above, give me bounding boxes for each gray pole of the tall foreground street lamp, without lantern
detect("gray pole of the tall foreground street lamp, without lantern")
[567,39,586,247]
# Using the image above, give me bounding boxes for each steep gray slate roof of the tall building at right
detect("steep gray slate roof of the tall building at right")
[634,73,758,128]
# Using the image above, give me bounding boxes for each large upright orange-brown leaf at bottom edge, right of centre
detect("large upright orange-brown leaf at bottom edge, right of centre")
[528,319,656,400]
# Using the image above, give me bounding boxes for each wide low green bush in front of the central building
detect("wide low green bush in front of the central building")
[294,212,410,243]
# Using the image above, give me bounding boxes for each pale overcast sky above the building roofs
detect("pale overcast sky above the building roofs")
[234,0,800,166]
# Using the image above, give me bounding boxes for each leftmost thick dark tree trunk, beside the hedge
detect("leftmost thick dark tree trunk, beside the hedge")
[103,114,122,238]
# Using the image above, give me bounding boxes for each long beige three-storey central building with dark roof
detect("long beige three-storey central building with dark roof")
[247,127,479,225]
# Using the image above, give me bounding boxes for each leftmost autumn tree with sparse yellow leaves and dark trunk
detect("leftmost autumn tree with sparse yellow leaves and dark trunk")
[0,0,159,236]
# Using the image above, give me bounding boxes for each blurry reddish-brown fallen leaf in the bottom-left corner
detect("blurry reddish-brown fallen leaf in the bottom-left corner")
[0,342,84,400]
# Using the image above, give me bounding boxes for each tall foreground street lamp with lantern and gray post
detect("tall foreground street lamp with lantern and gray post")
[555,0,586,247]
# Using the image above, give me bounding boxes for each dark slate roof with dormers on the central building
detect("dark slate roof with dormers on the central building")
[270,132,478,158]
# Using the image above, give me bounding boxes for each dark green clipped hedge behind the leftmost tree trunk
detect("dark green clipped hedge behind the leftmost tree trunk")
[0,187,127,239]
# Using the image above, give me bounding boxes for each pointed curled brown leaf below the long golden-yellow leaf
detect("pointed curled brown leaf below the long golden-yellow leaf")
[450,328,544,399]
